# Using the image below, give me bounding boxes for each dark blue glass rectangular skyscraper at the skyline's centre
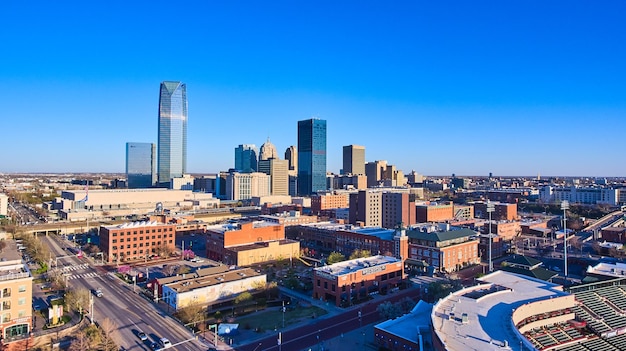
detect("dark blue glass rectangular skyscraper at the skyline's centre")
[298,118,326,196]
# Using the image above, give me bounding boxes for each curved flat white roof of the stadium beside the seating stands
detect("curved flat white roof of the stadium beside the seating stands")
[431,271,569,351]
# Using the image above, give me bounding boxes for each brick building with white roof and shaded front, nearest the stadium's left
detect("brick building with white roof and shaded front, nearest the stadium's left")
[313,255,404,306]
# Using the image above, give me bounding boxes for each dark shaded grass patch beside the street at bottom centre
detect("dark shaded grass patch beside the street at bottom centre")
[236,306,328,333]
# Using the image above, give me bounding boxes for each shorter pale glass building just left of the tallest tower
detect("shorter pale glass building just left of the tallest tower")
[126,143,156,189]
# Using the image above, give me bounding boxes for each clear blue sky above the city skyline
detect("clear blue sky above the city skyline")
[0,0,626,176]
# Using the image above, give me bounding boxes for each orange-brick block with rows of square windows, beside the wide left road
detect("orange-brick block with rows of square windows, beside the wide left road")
[99,221,176,263]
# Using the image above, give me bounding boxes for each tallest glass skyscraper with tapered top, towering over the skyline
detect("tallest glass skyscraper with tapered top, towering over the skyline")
[158,82,187,187]
